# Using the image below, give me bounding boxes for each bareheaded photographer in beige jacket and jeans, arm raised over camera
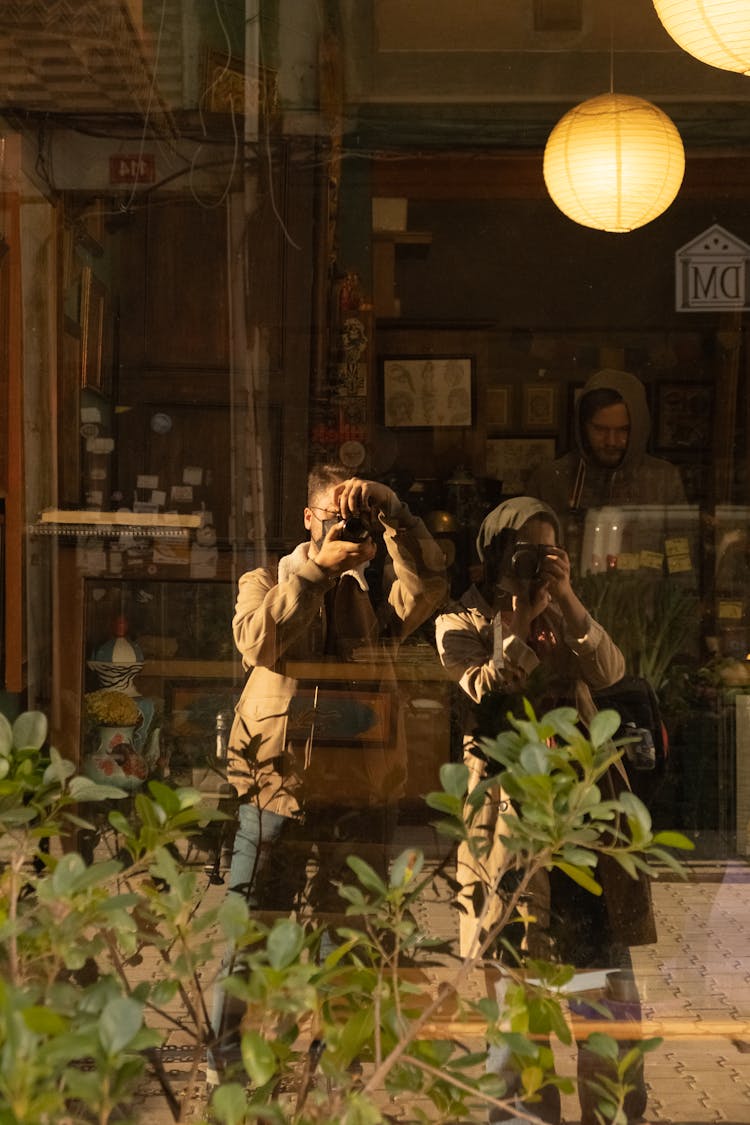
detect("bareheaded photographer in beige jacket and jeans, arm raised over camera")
[209,465,448,1082]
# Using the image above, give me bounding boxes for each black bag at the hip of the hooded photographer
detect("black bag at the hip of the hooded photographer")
[591,676,668,773]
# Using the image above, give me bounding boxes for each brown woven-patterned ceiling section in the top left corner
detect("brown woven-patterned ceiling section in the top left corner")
[0,0,173,117]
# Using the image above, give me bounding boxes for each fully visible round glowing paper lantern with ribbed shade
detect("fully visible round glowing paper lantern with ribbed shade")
[544,93,685,232]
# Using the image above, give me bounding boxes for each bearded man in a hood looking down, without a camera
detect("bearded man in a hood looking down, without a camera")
[527,368,687,515]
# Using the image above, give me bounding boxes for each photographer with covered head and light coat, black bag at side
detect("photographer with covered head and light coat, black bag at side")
[435,496,656,1125]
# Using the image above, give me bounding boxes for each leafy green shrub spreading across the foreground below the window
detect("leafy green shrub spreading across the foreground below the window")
[0,710,687,1125]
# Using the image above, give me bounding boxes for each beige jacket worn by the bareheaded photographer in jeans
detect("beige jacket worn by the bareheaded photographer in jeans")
[229,503,446,816]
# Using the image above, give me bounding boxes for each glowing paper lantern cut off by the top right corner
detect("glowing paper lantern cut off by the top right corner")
[653,0,750,74]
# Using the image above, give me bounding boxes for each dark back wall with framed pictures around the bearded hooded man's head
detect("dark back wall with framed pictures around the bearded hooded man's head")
[377,321,720,503]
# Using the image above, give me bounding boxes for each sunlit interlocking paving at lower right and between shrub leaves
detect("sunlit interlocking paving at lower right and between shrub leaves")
[132,846,750,1125]
